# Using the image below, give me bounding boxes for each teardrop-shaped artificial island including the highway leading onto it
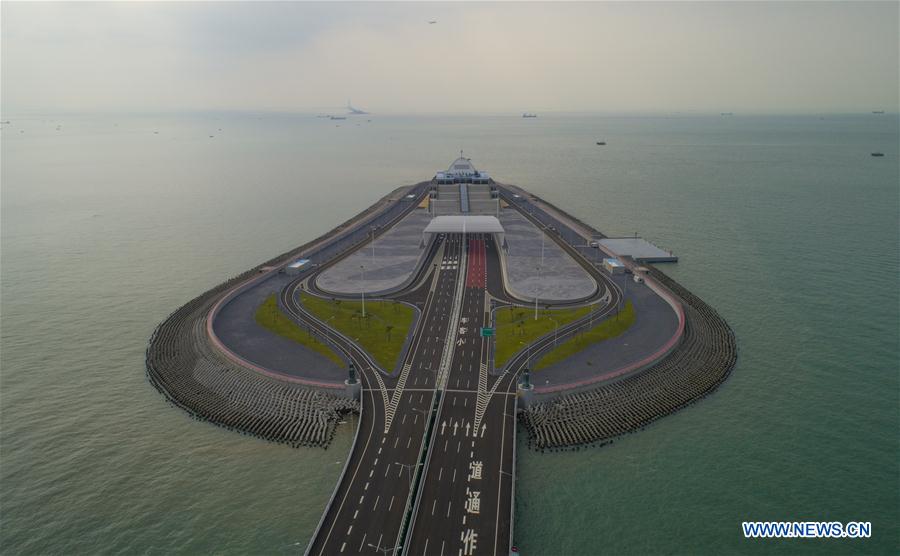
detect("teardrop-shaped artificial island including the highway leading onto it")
[146,155,737,556]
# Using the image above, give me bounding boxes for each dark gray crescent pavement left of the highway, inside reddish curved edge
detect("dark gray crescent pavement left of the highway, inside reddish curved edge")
[214,274,347,382]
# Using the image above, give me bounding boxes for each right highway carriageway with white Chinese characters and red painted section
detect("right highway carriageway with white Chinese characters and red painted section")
[403,234,516,556]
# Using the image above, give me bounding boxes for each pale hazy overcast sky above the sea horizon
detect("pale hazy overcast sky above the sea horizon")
[0,1,900,115]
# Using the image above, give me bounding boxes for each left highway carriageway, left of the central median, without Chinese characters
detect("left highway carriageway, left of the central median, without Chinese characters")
[306,232,463,554]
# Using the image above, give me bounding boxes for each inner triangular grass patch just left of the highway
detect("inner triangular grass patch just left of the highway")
[300,292,413,372]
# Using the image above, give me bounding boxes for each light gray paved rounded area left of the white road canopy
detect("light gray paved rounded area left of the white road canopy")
[316,209,431,294]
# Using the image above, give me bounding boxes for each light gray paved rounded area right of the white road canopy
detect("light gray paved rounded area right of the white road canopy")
[500,208,596,301]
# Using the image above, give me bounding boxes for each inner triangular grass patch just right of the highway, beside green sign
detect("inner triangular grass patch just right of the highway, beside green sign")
[494,307,591,369]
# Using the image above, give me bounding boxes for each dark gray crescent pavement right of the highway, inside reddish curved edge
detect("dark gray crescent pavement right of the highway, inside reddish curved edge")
[533,274,678,386]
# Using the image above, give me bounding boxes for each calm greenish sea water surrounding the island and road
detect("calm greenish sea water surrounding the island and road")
[0,114,900,554]
